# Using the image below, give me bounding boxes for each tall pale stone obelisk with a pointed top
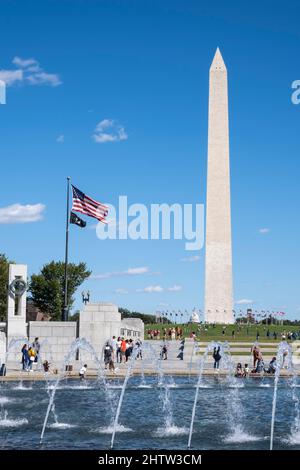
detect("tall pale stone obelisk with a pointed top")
[204,48,234,323]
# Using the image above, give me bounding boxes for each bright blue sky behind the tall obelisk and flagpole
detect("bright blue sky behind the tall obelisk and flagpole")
[0,0,300,318]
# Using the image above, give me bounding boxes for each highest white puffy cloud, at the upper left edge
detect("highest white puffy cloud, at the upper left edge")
[0,57,62,87]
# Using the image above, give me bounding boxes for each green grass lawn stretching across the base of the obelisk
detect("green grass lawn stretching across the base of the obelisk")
[145,323,300,343]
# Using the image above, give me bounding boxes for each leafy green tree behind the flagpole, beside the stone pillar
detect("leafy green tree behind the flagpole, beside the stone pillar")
[29,261,91,320]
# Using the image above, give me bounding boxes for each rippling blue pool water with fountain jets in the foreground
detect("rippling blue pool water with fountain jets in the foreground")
[0,377,300,450]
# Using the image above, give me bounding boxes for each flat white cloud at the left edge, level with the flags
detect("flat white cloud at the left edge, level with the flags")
[0,204,45,224]
